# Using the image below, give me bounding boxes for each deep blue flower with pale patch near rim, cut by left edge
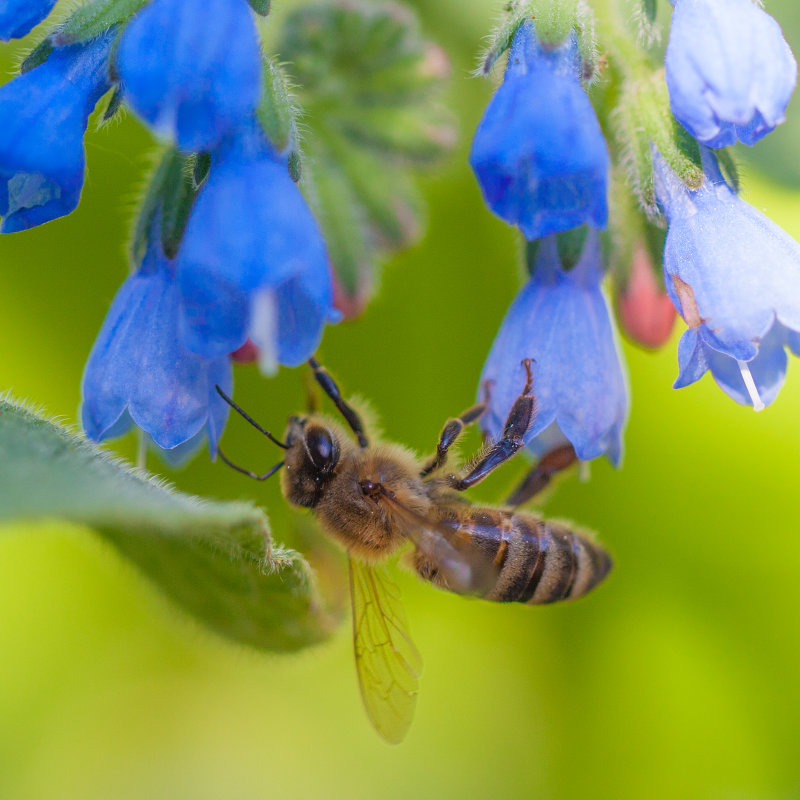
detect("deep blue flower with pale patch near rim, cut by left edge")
[0,31,114,233]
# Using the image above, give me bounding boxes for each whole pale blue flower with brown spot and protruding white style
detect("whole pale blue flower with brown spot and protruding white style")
[654,148,800,408]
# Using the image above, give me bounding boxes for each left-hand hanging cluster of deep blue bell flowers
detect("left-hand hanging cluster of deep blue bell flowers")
[0,0,336,455]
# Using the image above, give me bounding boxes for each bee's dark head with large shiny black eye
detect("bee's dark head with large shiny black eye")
[281,416,341,508]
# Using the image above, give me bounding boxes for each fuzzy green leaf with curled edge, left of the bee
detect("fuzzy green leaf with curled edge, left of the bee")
[0,399,335,651]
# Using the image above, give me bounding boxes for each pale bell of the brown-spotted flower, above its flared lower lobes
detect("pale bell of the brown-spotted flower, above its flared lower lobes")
[655,149,800,361]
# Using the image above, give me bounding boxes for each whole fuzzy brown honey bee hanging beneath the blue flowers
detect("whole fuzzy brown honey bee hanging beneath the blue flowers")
[217,358,611,743]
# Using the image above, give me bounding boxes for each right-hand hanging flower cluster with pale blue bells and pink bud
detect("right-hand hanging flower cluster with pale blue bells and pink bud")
[471,0,800,476]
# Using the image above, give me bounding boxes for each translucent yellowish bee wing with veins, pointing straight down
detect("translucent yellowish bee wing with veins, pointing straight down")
[350,558,422,744]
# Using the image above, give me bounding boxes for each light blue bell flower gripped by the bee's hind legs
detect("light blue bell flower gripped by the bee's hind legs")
[481,231,628,464]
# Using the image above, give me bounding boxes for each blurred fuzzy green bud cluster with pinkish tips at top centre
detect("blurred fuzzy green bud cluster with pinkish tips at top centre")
[278,2,454,298]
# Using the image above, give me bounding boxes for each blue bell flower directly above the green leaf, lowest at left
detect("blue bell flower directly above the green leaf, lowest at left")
[81,231,233,456]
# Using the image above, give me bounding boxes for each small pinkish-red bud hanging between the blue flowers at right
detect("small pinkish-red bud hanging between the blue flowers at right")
[617,243,676,349]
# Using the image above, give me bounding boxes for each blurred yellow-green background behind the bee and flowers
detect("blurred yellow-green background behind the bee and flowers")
[0,0,800,800]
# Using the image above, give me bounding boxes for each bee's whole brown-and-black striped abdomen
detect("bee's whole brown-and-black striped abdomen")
[414,505,612,604]
